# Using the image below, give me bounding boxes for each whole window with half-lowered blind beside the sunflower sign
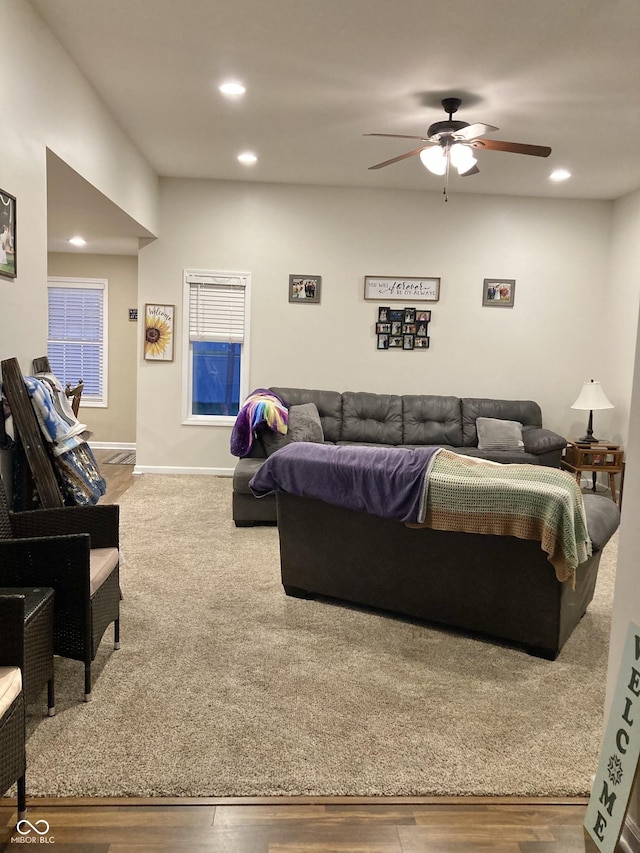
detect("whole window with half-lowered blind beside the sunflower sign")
[184,271,250,422]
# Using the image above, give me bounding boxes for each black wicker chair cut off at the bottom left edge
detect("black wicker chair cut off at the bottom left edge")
[0,595,27,820]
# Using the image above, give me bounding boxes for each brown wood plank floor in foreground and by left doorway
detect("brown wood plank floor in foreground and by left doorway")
[0,451,596,853]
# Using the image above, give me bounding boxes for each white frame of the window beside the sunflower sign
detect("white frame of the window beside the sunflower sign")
[181,269,251,427]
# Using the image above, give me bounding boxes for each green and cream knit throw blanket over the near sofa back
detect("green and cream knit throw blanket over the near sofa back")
[412,450,591,586]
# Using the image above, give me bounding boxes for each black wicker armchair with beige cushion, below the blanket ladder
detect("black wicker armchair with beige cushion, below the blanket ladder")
[0,482,121,701]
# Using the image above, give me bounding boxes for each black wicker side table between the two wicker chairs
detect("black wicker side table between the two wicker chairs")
[0,587,56,717]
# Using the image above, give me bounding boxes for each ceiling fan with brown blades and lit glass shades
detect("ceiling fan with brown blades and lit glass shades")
[364,98,551,197]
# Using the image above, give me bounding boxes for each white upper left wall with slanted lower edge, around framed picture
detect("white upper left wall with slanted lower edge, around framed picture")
[0,0,158,371]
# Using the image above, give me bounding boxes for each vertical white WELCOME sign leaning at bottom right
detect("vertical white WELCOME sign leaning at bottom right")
[584,622,640,853]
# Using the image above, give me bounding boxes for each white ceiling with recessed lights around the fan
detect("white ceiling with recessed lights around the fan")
[31,0,640,253]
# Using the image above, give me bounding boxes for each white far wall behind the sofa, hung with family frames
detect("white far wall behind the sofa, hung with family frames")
[137,179,616,470]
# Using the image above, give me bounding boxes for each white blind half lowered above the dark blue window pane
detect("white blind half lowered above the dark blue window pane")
[187,276,246,343]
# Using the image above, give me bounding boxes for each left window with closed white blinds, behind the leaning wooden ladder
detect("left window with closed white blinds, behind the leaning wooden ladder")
[47,278,107,406]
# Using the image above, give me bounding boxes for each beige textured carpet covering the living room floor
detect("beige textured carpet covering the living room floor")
[27,475,615,796]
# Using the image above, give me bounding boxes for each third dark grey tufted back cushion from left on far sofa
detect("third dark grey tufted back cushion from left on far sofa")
[402,394,462,447]
